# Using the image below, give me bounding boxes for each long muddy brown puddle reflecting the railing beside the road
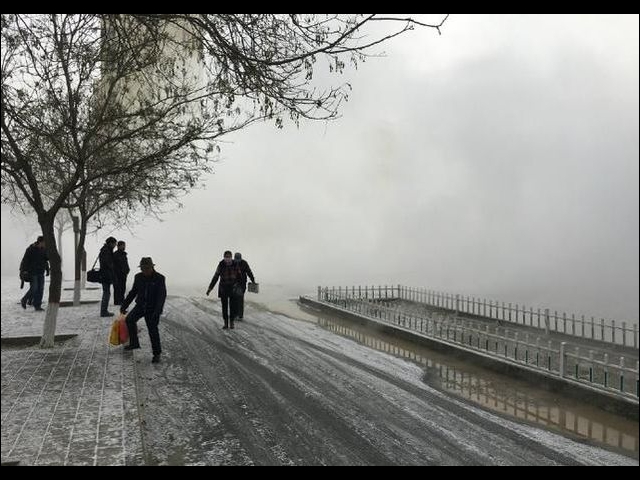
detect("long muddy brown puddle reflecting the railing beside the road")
[306,309,639,459]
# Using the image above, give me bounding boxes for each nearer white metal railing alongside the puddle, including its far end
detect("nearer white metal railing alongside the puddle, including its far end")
[318,286,639,400]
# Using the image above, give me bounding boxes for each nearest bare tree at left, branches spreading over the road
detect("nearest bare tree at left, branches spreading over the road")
[1,14,444,347]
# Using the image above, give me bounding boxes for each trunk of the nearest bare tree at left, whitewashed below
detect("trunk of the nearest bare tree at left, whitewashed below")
[39,216,62,348]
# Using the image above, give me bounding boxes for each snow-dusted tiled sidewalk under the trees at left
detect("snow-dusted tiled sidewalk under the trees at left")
[2,305,144,465]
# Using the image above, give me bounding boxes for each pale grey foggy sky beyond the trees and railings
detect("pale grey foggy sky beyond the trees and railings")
[2,15,639,321]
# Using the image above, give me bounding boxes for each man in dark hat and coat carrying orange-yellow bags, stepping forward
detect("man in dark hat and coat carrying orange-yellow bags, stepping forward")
[120,257,167,363]
